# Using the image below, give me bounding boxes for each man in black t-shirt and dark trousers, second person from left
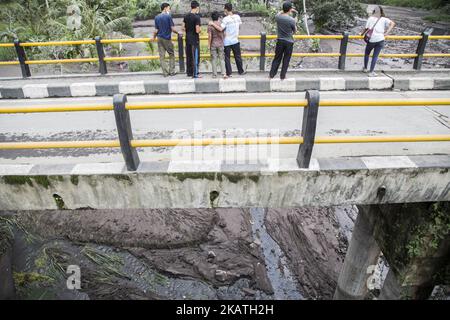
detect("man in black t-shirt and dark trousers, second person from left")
[183,1,201,78]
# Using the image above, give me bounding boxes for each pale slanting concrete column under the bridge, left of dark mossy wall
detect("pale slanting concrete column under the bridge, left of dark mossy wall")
[333,206,380,300]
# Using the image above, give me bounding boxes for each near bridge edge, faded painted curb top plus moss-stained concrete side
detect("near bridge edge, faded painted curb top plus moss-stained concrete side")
[0,155,450,210]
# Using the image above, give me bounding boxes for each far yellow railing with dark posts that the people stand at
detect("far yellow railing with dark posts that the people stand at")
[0,30,450,78]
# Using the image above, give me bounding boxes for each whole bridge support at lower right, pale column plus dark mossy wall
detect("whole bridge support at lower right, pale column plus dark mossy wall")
[334,202,450,300]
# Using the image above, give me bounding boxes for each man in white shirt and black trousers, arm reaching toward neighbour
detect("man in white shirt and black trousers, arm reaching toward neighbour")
[210,3,245,76]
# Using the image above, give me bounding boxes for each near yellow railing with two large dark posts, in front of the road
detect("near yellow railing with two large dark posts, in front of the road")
[0,90,450,171]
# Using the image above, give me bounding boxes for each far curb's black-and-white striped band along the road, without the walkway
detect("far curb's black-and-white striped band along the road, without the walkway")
[0,74,450,99]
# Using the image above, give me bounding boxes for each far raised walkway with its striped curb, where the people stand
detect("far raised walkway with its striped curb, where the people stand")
[0,69,450,99]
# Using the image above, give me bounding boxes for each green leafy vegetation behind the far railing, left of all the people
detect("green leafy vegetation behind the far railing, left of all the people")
[0,0,136,60]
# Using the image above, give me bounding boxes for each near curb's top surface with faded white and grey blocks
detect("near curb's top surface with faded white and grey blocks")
[0,154,450,177]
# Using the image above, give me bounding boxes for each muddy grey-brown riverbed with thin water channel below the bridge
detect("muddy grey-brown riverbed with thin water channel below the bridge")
[0,207,356,299]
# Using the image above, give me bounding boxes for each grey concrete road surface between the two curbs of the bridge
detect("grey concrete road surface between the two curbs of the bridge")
[0,90,450,164]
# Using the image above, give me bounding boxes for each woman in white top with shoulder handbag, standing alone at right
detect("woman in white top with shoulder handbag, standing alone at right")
[361,6,395,77]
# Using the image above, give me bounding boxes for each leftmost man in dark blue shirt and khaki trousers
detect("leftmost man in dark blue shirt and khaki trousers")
[153,2,179,77]
